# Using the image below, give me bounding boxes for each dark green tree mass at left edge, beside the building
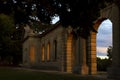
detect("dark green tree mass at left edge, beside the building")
[0,14,23,65]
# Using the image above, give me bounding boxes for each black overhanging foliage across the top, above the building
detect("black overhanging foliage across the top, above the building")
[0,0,116,38]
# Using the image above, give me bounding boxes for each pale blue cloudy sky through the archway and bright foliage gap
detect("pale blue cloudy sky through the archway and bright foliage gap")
[52,17,112,58]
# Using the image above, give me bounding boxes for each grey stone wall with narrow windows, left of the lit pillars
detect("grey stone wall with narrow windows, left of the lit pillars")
[23,24,64,70]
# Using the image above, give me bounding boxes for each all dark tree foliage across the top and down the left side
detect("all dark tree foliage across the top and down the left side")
[0,0,115,63]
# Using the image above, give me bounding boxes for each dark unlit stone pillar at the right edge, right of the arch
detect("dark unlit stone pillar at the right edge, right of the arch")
[108,3,120,80]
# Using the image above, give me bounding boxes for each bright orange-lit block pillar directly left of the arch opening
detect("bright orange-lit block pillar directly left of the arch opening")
[88,32,97,75]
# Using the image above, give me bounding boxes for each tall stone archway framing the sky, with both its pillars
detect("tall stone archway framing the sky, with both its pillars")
[90,4,120,80]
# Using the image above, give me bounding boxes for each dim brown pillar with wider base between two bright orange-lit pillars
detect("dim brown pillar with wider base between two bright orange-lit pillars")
[80,38,88,75]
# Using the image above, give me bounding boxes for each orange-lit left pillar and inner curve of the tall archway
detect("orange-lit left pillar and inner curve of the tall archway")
[90,18,111,74]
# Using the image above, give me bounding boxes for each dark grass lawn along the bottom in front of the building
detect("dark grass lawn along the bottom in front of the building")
[0,67,107,80]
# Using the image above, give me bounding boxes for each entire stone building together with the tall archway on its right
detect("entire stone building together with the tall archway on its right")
[23,3,120,80]
